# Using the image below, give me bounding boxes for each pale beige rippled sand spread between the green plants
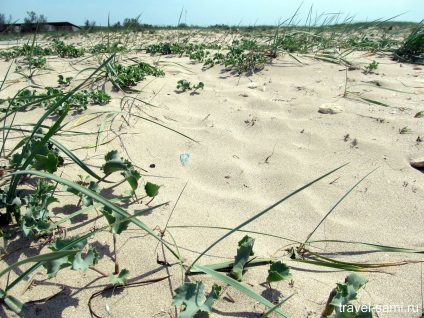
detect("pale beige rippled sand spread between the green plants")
[0,31,424,317]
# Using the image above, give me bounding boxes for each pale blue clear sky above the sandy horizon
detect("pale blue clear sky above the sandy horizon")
[0,0,424,26]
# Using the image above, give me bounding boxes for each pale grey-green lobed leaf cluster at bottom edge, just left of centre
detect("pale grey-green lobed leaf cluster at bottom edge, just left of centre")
[172,282,221,318]
